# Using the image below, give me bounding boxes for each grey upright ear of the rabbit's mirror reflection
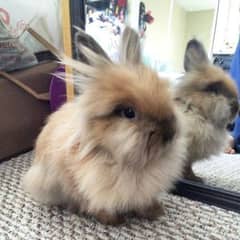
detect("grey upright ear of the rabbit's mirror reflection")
[184,39,209,72]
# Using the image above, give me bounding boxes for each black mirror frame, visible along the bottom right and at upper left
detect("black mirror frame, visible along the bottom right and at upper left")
[70,0,240,213]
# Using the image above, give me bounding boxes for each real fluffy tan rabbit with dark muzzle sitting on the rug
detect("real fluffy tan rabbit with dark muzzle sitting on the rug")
[23,27,185,224]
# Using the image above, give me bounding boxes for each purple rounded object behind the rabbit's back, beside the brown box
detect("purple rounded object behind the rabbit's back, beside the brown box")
[49,66,67,112]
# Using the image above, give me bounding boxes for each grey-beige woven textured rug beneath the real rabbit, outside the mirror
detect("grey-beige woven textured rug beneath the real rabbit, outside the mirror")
[0,152,240,240]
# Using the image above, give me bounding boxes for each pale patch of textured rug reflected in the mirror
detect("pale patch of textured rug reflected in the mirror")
[193,154,240,193]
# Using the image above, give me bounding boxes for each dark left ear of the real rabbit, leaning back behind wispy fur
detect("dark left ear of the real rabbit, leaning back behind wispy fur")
[74,26,111,63]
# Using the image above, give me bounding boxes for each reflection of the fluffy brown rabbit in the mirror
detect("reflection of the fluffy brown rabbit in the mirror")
[176,39,238,181]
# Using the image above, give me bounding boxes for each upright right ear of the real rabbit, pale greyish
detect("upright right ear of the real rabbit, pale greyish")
[119,26,142,65]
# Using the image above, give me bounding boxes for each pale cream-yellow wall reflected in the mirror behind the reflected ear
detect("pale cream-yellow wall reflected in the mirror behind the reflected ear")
[169,7,214,72]
